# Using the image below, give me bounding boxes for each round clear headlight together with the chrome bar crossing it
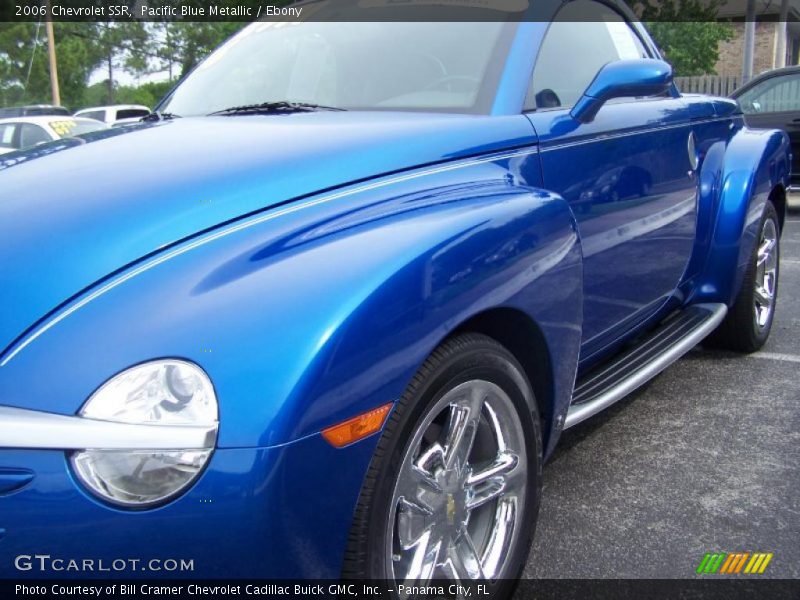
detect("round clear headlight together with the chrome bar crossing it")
[0,358,219,509]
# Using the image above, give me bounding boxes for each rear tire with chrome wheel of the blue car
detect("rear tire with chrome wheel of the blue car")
[708,202,780,353]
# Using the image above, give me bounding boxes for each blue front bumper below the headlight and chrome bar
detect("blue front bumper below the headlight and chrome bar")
[0,435,376,579]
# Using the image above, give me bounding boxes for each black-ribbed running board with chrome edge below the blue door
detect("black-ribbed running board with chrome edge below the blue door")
[564,304,728,429]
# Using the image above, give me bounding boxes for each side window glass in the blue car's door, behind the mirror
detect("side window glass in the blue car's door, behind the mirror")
[525,0,648,110]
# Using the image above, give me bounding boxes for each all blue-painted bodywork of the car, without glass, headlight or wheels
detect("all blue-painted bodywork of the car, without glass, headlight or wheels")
[0,8,789,577]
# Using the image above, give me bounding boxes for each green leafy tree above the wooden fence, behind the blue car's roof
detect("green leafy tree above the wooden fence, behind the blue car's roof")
[634,0,733,76]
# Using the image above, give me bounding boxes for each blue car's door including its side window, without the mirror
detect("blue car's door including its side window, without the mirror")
[526,0,697,366]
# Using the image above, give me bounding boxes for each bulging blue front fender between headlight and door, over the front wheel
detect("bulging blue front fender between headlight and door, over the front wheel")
[0,150,581,448]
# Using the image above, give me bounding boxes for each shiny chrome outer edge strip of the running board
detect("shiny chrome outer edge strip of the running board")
[564,303,728,429]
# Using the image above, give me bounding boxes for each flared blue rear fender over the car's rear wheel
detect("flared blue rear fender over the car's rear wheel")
[693,128,791,306]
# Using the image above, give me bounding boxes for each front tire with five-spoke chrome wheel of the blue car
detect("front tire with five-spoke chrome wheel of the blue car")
[342,334,542,598]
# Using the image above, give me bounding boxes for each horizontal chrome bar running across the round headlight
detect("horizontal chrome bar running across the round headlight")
[0,406,218,450]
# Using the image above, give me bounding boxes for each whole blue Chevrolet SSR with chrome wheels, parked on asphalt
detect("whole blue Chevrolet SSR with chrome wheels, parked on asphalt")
[0,0,791,594]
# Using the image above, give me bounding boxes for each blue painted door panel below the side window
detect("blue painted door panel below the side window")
[528,97,696,366]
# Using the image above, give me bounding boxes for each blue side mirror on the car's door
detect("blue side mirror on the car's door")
[570,58,672,123]
